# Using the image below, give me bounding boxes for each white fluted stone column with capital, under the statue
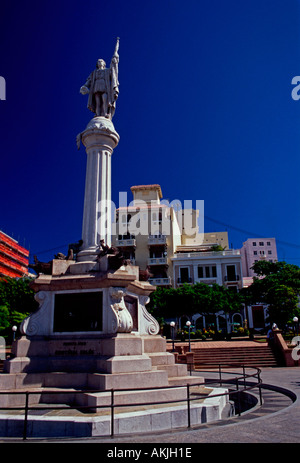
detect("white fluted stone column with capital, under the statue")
[77,117,120,262]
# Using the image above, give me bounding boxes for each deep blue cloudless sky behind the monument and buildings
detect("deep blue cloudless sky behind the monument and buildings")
[0,0,300,265]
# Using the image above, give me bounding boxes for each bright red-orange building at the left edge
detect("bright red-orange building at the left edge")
[0,231,29,278]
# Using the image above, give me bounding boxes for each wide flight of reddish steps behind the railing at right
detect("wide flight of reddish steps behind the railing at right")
[188,343,281,370]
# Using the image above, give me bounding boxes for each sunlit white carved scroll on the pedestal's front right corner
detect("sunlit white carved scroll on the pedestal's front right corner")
[109,288,133,333]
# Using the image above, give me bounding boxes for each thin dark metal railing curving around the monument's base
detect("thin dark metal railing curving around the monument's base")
[0,364,263,440]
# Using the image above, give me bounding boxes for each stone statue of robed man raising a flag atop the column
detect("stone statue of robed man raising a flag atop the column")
[80,38,119,120]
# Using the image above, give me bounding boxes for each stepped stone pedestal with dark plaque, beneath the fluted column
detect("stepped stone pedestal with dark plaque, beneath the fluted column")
[0,256,201,407]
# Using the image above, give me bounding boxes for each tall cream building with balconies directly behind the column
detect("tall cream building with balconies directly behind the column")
[112,185,181,286]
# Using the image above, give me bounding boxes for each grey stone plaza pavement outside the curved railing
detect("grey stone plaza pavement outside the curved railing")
[19,367,300,446]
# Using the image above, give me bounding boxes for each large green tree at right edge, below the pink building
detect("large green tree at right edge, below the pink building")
[242,261,300,327]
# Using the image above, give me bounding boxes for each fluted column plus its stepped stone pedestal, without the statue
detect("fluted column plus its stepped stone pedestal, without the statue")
[0,117,202,414]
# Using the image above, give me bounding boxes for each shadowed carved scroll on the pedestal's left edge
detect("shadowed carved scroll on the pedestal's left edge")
[20,291,51,336]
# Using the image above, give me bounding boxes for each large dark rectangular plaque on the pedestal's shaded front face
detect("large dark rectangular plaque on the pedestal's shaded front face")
[53,292,103,332]
